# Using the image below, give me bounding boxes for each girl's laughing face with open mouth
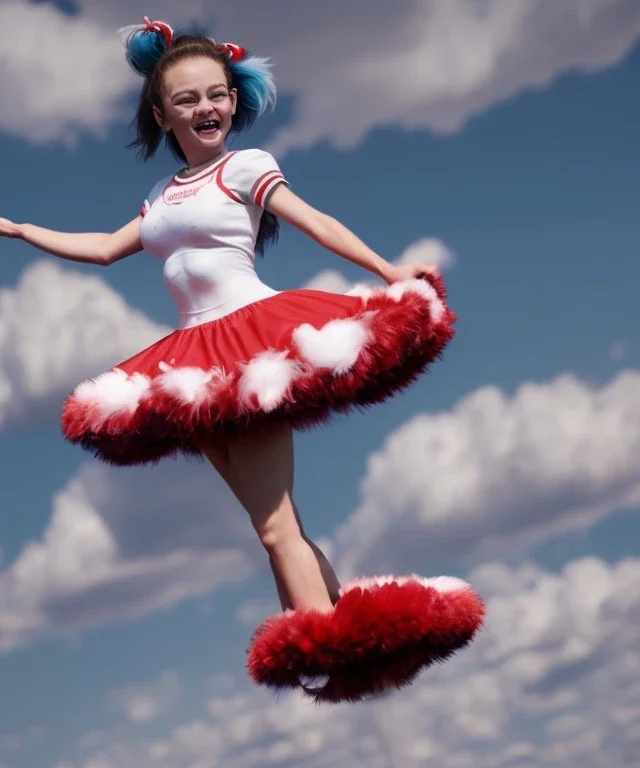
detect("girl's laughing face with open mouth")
[154,57,237,167]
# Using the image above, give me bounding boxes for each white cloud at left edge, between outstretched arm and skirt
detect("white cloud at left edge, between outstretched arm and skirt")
[0,260,171,428]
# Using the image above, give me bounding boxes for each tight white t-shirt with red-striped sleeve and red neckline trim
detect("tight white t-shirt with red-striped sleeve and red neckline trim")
[140,149,286,328]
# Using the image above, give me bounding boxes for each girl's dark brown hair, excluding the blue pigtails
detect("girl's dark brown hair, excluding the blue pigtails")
[128,35,280,255]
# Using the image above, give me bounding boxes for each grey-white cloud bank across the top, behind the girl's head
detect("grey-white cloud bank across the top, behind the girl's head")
[0,0,640,155]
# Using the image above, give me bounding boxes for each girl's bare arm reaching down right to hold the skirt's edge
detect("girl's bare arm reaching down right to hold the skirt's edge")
[267,184,437,284]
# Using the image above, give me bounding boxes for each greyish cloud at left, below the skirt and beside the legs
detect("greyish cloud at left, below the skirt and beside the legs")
[0,461,262,652]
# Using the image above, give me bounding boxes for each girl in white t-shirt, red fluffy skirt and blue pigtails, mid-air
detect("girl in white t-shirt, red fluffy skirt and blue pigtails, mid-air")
[0,19,483,701]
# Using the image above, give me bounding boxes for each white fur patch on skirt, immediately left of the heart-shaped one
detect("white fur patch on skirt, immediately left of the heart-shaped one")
[239,351,300,413]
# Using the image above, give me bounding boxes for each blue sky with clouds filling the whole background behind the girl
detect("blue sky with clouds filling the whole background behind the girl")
[0,0,640,768]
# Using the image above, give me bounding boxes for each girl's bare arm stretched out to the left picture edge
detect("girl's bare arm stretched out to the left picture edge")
[0,216,142,267]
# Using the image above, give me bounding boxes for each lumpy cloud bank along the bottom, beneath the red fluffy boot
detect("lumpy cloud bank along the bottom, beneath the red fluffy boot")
[57,558,640,768]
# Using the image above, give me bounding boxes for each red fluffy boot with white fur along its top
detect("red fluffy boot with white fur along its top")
[247,576,484,702]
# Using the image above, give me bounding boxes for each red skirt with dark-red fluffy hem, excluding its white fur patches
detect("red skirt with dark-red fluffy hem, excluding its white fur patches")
[62,279,455,465]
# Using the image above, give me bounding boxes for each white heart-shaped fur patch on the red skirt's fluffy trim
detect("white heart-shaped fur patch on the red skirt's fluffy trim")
[293,319,370,373]
